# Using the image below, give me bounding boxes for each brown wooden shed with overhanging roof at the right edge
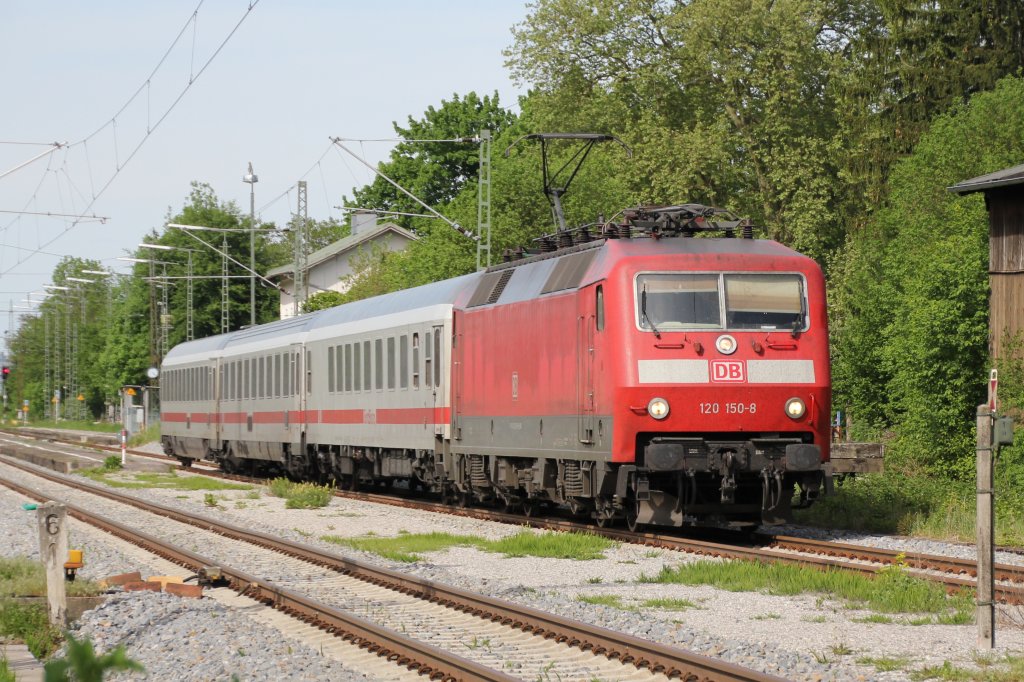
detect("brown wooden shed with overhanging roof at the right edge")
[949,164,1024,357]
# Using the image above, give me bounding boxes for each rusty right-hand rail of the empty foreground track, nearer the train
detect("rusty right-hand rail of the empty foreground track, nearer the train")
[2,450,781,682]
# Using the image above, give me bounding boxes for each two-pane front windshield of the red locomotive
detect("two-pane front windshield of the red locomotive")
[636,272,807,332]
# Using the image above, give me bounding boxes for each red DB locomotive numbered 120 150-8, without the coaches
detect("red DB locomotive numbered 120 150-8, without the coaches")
[447,205,831,527]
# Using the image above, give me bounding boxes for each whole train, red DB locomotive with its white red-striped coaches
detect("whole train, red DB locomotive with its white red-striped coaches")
[162,205,831,528]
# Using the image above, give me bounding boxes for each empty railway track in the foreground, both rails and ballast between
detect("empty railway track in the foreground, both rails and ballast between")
[2,450,778,680]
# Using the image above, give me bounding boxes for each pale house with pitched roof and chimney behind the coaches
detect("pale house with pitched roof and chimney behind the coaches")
[266,212,418,319]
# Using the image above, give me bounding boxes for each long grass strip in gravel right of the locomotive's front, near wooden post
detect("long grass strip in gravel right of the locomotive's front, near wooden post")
[640,561,973,622]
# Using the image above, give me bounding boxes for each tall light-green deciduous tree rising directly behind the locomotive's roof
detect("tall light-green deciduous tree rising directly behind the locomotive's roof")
[508,0,843,258]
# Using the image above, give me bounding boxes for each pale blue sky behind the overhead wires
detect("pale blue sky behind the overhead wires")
[0,0,526,339]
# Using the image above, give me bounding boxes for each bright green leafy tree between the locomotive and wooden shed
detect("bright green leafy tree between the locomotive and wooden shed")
[833,78,1024,475]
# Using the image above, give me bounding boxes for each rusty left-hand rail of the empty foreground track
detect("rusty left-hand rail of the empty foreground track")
[0,472,503,682]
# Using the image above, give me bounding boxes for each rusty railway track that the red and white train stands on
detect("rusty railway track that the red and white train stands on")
[8,431,1024,604]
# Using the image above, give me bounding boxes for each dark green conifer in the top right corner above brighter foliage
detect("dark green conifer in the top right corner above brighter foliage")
[830,0,1024,229]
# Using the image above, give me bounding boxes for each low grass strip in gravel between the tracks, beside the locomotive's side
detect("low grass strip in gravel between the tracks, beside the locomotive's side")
[322,530,615,563]
